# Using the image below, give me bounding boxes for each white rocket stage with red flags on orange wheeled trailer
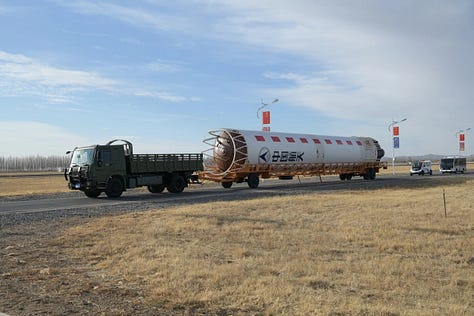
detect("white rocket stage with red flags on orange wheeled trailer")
[199,128,387,188]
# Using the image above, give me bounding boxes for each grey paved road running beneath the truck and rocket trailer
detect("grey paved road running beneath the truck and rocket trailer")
[0,173,474,215]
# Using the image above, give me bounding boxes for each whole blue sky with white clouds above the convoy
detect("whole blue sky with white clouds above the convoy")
[0,0,474,156]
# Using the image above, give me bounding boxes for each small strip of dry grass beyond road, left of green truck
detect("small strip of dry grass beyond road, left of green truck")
[0,175,69,196]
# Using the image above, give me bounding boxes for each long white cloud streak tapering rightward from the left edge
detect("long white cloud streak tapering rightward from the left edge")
[0,51,199,103]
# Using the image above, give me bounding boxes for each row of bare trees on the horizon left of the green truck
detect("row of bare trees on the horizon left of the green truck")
[0,156,70,172]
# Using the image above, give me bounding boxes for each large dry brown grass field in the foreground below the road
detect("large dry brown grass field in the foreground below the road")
[58,180,474,315]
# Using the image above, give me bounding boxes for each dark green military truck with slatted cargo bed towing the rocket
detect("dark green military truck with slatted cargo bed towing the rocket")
[64,139,203,198]
